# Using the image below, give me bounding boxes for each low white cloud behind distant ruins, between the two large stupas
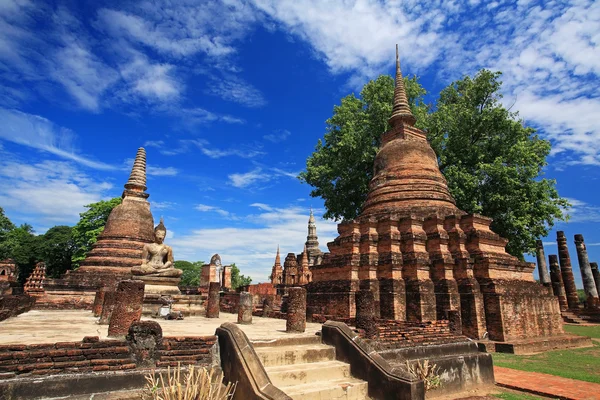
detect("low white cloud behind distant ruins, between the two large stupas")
[170,203,337,283]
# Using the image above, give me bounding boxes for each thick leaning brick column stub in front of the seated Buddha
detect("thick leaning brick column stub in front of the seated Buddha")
[108,279,145,337]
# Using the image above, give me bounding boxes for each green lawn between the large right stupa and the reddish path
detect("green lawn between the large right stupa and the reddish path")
[492,340,600,383]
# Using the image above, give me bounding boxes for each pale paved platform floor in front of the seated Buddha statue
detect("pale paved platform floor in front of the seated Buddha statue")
[0,310,321,344]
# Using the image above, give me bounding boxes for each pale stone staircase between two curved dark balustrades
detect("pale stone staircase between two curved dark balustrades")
[253,336,369,400]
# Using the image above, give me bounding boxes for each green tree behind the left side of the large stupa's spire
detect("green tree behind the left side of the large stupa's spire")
[299,75,428,220]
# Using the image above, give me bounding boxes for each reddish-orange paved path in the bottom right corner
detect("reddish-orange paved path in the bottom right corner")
[494,367,600,400]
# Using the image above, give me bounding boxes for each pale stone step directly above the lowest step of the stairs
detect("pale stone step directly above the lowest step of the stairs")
[266,361,351,387]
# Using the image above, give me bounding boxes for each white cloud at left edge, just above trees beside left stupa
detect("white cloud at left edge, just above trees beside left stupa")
[0,160,113,226]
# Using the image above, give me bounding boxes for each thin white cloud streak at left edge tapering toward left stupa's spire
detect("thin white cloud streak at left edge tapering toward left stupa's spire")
[0,108,117,170]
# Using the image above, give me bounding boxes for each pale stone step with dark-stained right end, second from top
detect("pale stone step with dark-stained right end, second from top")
[254,344,335,368]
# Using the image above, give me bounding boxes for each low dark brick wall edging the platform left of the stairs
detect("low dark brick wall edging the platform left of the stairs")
[0,336,217,378]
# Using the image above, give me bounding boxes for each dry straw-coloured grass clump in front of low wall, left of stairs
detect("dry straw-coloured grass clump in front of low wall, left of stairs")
[142,364,235,400]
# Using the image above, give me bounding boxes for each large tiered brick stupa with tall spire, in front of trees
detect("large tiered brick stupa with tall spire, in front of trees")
[306,48,564,341]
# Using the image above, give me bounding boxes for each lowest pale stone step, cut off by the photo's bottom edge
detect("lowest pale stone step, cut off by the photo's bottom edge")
[279,378,369,400]
